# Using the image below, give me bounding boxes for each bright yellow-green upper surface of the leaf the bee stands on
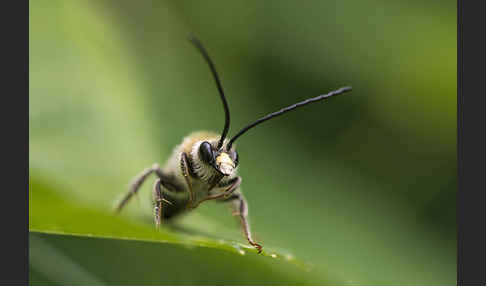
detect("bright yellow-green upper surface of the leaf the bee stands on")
[29,180,292,258]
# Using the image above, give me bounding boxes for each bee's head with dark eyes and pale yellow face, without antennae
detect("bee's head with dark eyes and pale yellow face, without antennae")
[199,141,238,176]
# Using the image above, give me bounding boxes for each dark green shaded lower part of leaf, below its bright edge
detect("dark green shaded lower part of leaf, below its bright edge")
[30,233,326,285]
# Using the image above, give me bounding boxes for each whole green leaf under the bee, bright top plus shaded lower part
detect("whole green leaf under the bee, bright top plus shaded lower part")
[29,180,334,285]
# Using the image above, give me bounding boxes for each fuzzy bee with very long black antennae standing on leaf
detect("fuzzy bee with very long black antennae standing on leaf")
[116,35,351,253]
